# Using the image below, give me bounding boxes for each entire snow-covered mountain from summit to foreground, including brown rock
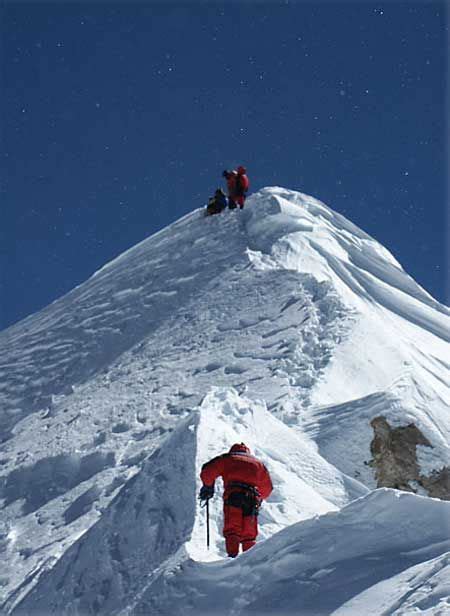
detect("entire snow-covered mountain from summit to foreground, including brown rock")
[0,188,450,615]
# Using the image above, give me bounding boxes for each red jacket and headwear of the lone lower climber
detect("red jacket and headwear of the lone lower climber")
[200,445,273,499]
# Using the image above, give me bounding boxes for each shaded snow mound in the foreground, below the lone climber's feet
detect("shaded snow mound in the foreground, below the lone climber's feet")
[125,489,450,616]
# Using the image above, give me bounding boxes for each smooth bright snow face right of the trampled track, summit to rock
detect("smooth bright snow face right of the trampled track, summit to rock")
[246,189,450,487]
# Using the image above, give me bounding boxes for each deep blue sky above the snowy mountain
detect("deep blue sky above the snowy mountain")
[0,1,448,329]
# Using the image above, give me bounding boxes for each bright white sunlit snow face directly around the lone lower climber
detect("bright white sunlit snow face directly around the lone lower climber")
[187,388,367,560]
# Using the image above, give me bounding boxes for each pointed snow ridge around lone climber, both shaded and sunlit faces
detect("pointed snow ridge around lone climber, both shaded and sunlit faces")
[4,388,367,616]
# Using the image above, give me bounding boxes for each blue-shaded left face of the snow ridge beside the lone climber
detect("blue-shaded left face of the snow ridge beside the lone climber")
[3,414,198,616]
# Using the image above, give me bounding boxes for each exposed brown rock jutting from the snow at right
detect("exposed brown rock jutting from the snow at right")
[370,416,450,500]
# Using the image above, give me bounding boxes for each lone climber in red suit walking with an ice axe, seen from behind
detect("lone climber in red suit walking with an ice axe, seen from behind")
[200,443,273,558]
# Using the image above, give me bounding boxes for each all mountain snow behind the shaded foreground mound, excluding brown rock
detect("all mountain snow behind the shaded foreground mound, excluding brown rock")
[0,188,449,613]
